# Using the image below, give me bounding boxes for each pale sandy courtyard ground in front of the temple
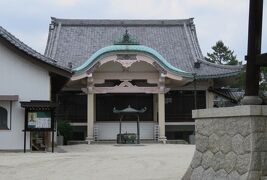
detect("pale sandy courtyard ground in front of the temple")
[0,144,195,180]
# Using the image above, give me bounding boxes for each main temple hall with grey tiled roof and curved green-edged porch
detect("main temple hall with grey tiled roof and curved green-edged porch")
[45,18,242,142]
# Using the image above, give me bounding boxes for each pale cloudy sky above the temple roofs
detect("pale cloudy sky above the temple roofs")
[0,0,267,60]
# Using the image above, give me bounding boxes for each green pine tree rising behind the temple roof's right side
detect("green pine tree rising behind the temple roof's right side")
[205,41,242,65]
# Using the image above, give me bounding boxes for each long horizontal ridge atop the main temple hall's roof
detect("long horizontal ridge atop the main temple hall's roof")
[51,17,194,26]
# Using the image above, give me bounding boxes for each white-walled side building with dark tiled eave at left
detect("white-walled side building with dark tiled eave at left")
[0,26,71,150]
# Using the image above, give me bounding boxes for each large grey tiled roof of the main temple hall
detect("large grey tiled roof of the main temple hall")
[45,18,242,78]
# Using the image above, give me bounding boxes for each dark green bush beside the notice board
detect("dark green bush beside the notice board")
[57,121,73,145]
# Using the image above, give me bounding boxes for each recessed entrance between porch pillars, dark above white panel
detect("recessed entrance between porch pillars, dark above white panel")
[94,93,157,140]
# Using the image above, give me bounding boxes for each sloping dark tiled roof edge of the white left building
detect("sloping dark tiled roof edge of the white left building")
[0,26,71,73]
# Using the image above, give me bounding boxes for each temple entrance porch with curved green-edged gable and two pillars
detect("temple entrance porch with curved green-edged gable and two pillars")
[65,48,192,143]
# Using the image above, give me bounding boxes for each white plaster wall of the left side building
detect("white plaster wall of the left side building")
[0,43,50,150]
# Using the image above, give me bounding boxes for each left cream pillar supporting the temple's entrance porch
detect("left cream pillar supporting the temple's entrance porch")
[87,93,95,144]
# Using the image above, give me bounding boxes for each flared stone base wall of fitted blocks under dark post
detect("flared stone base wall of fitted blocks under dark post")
[183,106,267,180]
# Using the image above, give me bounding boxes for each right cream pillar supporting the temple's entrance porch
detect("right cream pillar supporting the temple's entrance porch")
[158,93,167,144]
